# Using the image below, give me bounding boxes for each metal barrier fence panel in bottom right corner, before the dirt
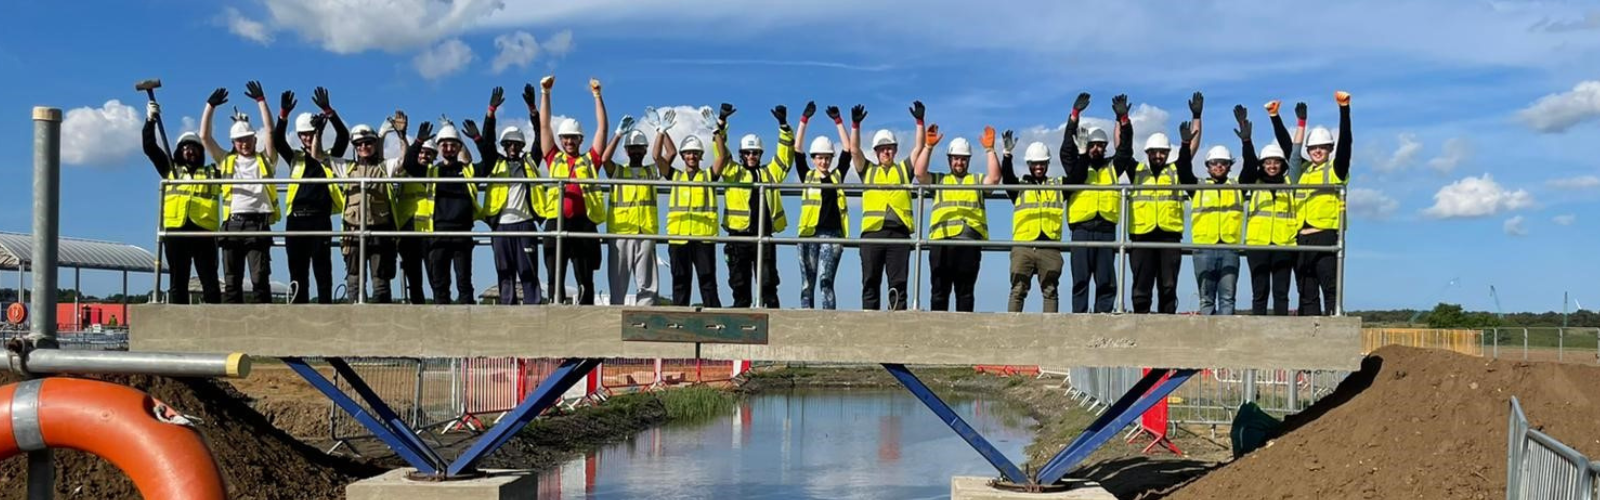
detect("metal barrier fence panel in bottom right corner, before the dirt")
[1506,396,1600,500]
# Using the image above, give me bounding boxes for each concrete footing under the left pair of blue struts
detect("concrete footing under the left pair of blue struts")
[344,468,539,500]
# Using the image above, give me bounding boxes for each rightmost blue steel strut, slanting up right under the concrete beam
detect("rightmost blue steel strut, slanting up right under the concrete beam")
[1038,369,1198,484]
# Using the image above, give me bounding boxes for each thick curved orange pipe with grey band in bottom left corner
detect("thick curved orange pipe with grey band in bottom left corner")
[0,378,227,500]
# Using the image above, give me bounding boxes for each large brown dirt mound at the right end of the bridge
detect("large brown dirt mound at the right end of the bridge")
[1166,346,1600,498]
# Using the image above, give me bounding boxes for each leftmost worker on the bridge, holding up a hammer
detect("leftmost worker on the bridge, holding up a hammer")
[142,101,222,304]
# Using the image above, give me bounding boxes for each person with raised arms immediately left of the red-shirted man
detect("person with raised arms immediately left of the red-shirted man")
[462,85,549,306]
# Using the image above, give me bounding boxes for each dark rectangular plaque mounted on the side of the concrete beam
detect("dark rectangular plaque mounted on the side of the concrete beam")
[622,311,766,345]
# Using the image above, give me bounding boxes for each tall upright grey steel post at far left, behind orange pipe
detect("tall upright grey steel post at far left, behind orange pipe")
[27,106,62,500]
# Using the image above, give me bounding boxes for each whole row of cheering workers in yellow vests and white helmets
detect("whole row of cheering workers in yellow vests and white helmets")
[144,77,1352,316]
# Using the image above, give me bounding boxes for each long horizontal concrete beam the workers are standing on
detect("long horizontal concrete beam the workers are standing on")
[130,304,1362,370]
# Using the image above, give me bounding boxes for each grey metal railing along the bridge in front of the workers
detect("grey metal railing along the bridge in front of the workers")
[152,178,1347,310]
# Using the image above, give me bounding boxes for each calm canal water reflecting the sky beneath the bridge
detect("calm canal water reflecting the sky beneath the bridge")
[539,389,1034,500]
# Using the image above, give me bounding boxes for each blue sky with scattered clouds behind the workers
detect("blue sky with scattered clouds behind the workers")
[0,0,1600,313]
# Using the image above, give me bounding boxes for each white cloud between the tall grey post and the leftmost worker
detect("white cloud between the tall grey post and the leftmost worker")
[61,99,144,167]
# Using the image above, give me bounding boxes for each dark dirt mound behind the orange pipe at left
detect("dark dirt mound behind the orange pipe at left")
[0,373,382,500]
